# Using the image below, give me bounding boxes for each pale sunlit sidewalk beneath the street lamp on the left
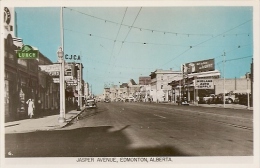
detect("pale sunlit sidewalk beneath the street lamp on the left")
[5,107,85,134]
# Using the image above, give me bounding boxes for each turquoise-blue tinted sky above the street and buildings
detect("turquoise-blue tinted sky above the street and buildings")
[15,6,253,94]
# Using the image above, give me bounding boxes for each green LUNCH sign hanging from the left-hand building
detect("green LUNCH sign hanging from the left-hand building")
[17,45,39,59]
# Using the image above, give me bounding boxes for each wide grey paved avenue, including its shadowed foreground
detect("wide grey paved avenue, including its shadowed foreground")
[6,103,253,157]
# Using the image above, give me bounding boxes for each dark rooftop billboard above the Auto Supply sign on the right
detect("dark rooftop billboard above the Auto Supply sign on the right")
[184,59,215,74]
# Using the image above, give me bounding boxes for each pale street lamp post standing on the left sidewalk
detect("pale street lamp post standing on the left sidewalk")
[57,47,66,123]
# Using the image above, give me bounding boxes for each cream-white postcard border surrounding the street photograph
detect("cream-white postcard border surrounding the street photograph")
[0,0,260,168]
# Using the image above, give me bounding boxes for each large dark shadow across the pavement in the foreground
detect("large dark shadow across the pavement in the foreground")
[5,125,187,158]
